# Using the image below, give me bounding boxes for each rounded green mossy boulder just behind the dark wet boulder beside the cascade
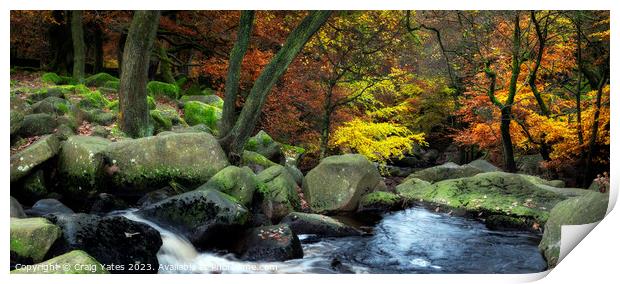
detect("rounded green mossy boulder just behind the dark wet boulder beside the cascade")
[197,166,256,206]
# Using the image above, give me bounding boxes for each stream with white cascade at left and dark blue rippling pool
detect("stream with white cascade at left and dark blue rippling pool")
[122,207,547,273]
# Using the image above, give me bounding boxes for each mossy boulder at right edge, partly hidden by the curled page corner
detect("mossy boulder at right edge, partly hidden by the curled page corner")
[538,191,609,268]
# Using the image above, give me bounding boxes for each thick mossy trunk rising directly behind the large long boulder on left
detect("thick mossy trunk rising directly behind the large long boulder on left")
[119,11,160,138]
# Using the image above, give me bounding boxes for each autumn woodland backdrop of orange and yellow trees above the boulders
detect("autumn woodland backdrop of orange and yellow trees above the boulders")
[11,11,610,185]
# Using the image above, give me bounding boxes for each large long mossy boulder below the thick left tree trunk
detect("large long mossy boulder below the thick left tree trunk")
[100,133,228,194]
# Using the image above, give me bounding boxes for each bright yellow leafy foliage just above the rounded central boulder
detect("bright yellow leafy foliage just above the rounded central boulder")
[332,118,427,165]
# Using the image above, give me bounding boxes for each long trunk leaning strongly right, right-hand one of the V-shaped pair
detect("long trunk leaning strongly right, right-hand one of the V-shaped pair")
[220,11,331,164]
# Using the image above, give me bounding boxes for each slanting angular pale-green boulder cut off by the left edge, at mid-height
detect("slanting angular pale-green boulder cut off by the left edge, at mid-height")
[11,135,60,182]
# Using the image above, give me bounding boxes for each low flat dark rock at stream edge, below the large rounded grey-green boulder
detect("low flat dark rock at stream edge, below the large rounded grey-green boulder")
[280,212,361,237]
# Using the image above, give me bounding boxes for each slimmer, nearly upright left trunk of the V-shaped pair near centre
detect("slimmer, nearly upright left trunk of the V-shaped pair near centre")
[220,11,254,137]
